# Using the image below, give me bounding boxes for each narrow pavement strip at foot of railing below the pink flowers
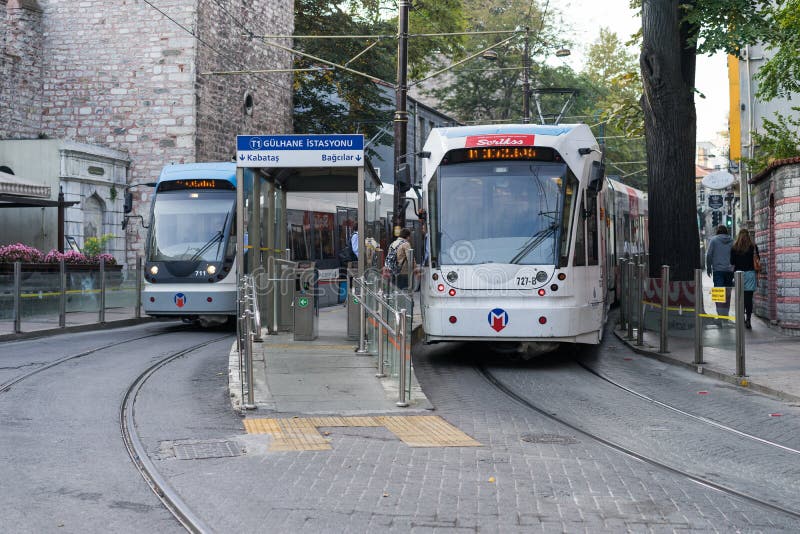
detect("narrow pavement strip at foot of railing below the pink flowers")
[0,307,152,341]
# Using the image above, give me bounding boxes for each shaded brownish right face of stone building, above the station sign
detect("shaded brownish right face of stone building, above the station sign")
[196,0,294,161]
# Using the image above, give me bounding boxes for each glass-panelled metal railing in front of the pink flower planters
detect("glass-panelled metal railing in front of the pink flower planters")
[0,258,142,333]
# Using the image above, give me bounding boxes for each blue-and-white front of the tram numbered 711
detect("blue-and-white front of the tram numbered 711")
[142,162,237,326]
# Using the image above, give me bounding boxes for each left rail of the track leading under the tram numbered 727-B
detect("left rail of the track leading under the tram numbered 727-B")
[476,365,800,519]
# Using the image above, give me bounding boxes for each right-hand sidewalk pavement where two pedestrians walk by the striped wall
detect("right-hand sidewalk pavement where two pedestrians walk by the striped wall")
[614,315,800,402]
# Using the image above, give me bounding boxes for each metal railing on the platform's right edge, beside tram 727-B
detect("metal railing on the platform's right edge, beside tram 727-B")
[350,272,411,407]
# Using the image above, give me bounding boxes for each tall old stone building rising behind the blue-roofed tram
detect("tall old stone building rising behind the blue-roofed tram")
[0,0,294,266]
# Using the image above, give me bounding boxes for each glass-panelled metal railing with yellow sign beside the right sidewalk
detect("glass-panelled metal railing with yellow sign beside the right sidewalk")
[618,257,746,378]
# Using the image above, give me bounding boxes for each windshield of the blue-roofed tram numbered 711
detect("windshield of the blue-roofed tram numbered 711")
[147,190,236,261]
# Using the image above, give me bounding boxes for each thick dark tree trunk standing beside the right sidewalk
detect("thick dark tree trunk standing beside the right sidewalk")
[639,0,701,281]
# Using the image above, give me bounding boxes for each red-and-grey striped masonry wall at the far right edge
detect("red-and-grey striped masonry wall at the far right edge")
[753,163,800,329]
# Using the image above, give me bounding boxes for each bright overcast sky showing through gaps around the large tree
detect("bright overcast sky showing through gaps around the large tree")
[545,0,729,141]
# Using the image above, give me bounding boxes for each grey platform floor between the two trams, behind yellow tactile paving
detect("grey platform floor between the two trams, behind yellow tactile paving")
[228,306,432,417]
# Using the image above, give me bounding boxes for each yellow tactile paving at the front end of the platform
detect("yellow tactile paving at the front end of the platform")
[244,415,481,451]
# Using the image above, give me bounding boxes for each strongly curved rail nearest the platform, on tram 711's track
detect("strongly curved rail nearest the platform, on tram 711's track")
[119,335,231,533]
